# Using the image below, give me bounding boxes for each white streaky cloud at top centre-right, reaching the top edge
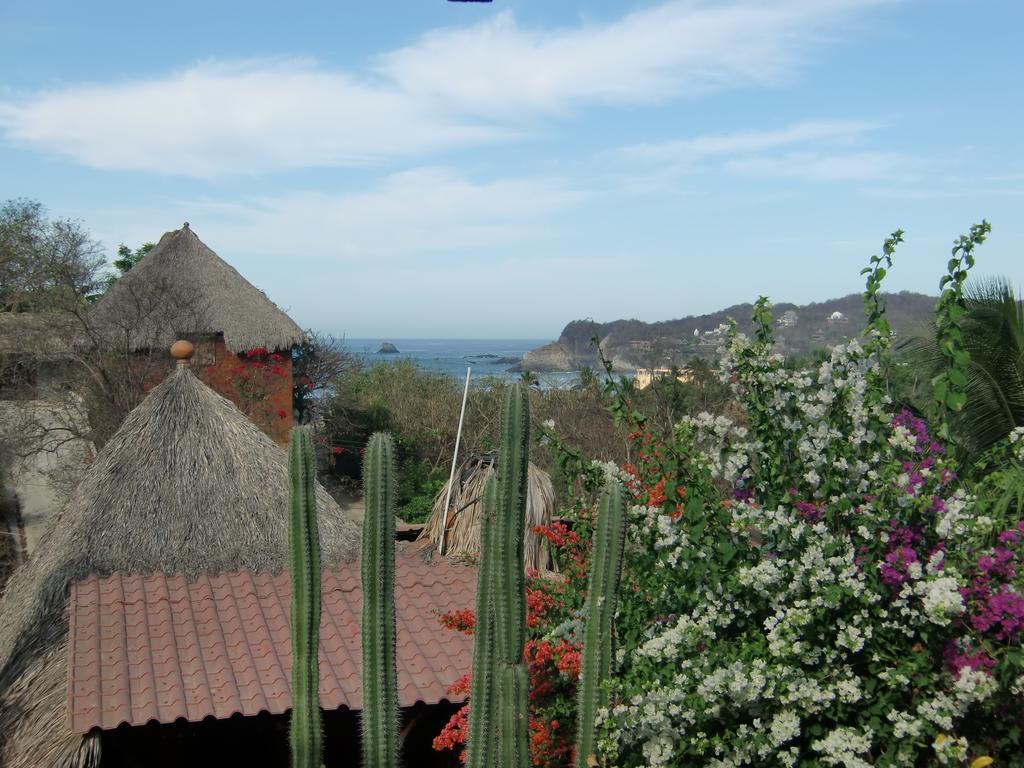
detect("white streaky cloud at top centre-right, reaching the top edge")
[380,0,877,117]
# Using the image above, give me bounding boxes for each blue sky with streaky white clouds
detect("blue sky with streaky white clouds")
[0,0,1024,339]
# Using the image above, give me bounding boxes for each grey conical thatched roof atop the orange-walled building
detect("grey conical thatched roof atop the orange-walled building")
[93,222,304,352]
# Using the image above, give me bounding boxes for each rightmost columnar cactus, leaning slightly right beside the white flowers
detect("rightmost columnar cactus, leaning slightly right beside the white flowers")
[575,480,626,768]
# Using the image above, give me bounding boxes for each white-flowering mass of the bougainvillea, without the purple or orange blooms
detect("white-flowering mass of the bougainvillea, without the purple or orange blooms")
[601,325,1003,768]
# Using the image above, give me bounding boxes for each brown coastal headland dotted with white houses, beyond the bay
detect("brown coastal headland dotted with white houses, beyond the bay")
[513,291,936,373]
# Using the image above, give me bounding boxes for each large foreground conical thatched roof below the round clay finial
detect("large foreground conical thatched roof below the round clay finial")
[0,366,359,768]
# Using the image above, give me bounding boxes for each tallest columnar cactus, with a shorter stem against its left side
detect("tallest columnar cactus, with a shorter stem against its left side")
[466,384,529,768]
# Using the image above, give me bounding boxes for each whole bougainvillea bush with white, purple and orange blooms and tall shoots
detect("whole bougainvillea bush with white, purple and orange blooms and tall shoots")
[434,225,1024,768]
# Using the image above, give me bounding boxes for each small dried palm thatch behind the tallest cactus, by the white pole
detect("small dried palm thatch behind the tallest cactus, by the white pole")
[418,454,555,570]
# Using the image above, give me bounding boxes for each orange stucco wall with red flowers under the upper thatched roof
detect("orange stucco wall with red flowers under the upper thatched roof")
[146,334,293,445]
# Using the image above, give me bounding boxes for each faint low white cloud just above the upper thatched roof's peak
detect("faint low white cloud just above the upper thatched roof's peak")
[82,168,587,268]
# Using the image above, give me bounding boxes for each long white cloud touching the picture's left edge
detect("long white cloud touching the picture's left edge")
[0,60,502,177]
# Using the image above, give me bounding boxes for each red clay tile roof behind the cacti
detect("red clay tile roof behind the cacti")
[68,546,476,733]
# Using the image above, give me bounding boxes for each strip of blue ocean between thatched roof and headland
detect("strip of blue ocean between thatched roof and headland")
[344,339,575,387]
